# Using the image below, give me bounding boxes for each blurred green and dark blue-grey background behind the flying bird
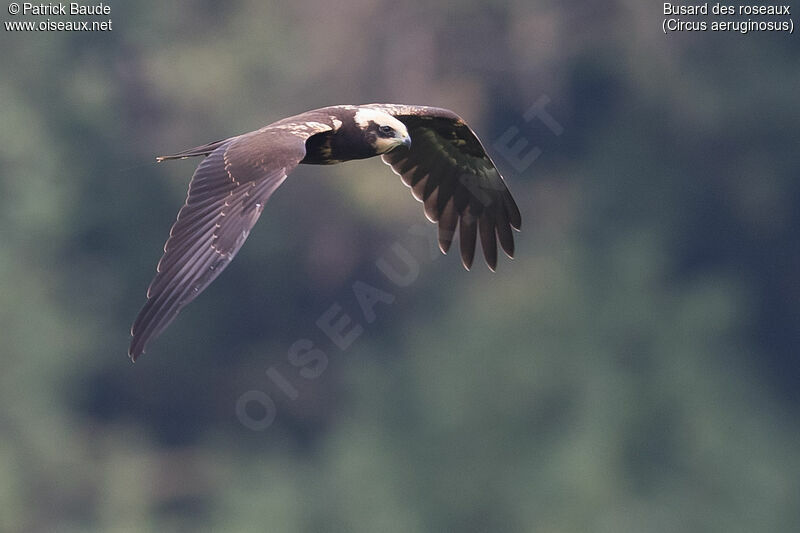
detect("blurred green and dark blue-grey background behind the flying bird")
[0,0,800,533]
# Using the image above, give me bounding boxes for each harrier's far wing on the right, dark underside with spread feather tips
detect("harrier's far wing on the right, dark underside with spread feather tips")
[368,104,522,270]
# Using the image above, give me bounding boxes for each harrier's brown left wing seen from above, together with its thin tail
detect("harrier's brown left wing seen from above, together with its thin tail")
[128,123,329,361]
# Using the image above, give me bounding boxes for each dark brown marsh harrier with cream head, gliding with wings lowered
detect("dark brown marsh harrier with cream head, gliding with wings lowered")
[128,104,522,361]
